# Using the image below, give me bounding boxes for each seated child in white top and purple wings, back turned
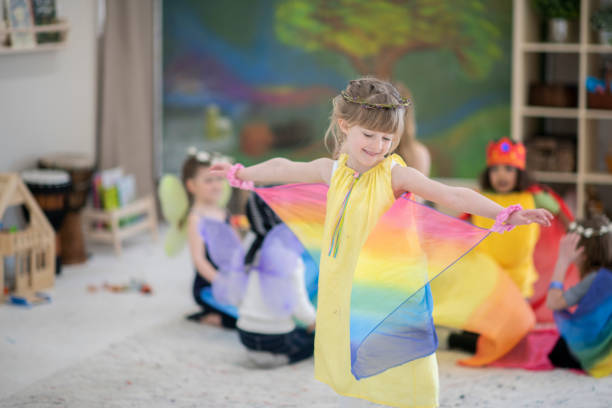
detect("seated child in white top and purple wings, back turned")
[237,193,315,367]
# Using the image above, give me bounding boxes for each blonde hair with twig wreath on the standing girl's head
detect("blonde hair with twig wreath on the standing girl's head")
[325,78,409,158]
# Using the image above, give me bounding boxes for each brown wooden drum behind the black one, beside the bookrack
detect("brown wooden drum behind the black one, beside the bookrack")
[38,154,94,265]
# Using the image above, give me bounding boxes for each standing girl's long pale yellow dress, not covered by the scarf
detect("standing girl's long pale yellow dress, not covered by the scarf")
[314,155,438,407]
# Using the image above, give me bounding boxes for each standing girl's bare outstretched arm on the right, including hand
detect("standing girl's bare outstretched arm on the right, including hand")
[391,166,553,226]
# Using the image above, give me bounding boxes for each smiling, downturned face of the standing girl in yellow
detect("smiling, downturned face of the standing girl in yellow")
[339,120,395,173]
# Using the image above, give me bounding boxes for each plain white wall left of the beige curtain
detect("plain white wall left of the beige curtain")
[0,0,98,172]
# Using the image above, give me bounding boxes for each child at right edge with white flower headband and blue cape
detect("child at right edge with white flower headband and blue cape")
[546,215,612,377]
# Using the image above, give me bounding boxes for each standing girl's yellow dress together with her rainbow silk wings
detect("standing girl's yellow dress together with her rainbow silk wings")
[256,155,488,407]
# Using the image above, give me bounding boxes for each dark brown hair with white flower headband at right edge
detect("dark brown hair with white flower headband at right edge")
[570,215,612,279]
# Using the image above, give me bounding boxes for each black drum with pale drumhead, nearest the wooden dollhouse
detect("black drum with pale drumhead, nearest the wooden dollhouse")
[21,169,72,275]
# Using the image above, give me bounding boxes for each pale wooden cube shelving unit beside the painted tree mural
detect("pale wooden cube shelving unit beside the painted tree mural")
[512,0,612,217]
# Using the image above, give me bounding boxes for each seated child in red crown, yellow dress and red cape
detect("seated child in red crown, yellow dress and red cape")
[448,137,576,353]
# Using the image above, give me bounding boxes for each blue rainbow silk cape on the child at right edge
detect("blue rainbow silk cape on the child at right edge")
[555,268,612,378]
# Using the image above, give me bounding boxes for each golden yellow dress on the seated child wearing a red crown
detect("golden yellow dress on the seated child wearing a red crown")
[472,192,540,298]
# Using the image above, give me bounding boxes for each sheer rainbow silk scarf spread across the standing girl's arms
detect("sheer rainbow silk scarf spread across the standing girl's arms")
[255,184,489,379]
